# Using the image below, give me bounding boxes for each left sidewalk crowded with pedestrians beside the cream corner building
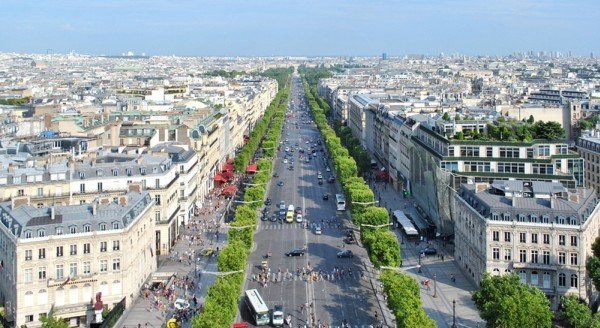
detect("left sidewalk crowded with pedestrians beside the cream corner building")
[115,186,236,328]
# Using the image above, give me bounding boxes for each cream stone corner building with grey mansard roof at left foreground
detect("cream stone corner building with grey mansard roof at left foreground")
[0,191,156,327]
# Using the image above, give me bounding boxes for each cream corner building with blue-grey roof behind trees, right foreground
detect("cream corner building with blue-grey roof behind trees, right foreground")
[454,180,600,307]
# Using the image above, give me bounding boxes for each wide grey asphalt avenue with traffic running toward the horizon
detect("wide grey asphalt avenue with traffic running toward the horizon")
[238,77,381,327]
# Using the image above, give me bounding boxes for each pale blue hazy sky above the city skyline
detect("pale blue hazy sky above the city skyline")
[0,0,600,56]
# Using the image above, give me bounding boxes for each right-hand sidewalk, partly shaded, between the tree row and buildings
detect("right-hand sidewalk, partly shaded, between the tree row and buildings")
[369,182,485,327]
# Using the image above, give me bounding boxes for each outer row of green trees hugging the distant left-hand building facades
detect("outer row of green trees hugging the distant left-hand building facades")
[234,68,290,173]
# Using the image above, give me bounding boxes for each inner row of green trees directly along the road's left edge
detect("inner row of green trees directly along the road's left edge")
[192,74,290,328]
